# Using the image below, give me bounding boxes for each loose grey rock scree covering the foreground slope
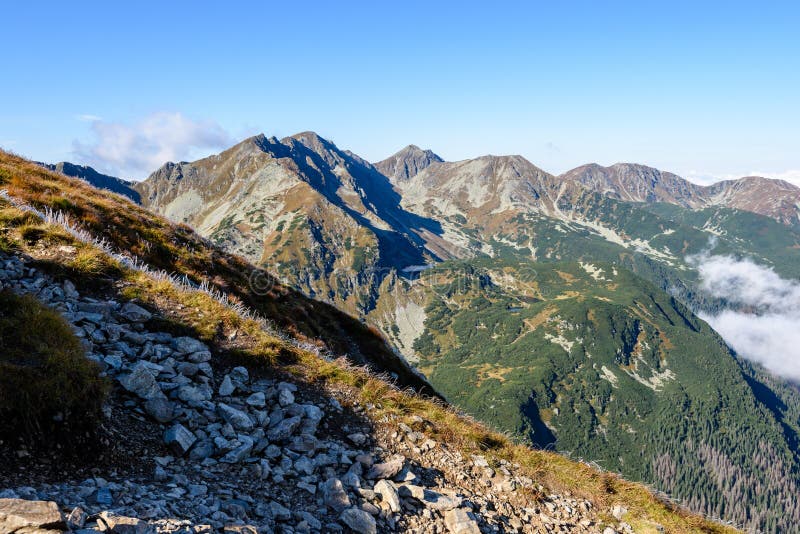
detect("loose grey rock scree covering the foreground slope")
[0,251,632,533]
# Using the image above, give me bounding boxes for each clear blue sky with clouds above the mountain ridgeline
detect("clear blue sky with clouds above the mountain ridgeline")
[0,0,800,183]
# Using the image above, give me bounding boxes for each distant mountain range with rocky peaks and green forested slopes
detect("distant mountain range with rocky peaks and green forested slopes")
[45,132,800,531]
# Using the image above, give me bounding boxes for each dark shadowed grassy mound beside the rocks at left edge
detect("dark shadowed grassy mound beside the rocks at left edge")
[0,290,107,447]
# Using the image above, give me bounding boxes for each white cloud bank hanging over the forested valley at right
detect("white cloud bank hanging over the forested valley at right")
[689,254,800,380]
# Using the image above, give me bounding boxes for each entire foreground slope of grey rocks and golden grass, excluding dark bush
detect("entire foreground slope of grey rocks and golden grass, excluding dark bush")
[0,151,725,534]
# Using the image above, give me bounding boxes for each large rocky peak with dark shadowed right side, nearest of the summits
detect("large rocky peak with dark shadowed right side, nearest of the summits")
[129,132,442,312]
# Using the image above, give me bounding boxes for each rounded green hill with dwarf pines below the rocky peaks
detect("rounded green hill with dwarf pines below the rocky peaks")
[415,260,800,531]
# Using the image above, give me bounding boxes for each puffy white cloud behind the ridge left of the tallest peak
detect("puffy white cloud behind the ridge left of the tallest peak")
[73,112,232,179]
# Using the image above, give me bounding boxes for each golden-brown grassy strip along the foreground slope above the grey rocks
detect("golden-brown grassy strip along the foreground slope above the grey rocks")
[0,153,733,533]
